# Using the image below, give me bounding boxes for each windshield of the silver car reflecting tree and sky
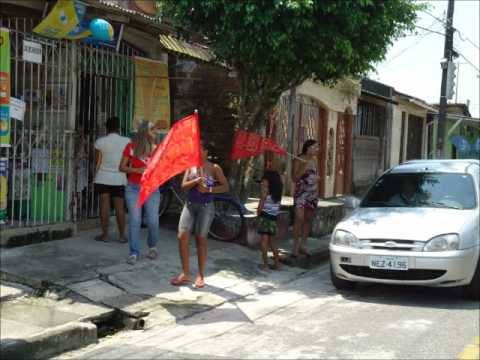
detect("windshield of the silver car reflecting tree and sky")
[360,173,476,209]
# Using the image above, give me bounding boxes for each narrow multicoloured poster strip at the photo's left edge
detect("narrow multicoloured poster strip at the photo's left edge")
[0,28,10,147]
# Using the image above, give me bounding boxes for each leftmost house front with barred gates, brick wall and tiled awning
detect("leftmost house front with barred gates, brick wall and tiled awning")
[0,0,237,241]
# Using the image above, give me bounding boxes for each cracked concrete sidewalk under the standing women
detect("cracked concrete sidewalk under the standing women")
[0,228,330,358]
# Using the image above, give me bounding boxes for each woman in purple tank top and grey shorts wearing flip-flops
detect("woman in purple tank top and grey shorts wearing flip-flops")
[171,141,229,288]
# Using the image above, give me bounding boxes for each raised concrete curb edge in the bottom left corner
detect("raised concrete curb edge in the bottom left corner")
[0,322,97,359]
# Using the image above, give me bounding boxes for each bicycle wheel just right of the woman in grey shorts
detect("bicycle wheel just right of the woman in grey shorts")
[209,199,245,241]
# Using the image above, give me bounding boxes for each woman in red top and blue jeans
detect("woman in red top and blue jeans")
[120,122,161,265]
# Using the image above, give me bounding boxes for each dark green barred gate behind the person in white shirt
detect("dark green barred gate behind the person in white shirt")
[70,43,143,221]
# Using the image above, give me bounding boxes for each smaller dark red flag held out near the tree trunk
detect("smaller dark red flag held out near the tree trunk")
[232,130,287,160]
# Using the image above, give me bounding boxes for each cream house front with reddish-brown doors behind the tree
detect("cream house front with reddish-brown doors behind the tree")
[268,79,360,198]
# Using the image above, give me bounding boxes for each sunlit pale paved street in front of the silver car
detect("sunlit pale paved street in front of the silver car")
[58,264,480,359]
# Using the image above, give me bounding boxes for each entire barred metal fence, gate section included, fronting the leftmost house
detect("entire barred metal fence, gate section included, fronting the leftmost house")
[0,18,144,227]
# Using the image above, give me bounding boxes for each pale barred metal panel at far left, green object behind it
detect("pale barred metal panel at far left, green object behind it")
[0,18,73,227]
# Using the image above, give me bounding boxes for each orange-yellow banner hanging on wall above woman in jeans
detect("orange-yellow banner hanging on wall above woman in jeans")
[133,57,170,133]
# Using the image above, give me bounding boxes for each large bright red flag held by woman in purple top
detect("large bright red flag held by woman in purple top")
[137,112,202,207]
